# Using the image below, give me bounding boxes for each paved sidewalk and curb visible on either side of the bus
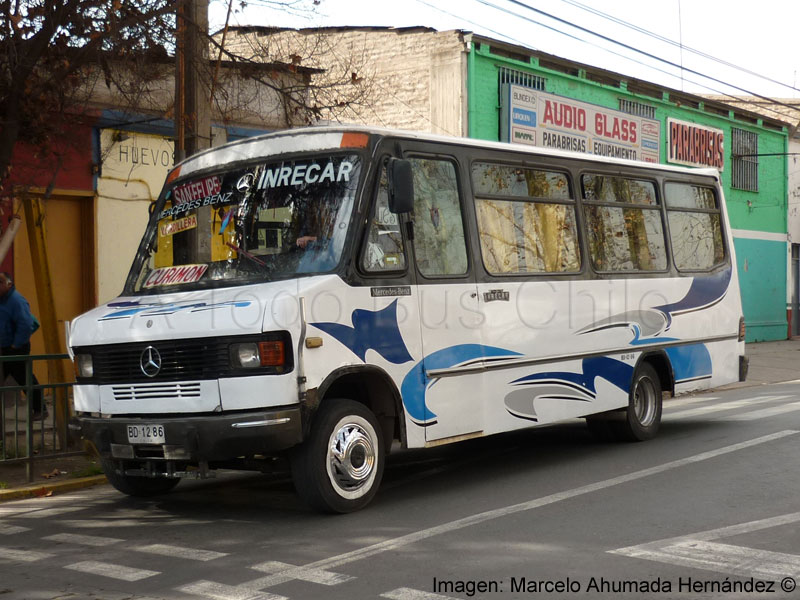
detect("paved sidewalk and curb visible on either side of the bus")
[0,338,800,502]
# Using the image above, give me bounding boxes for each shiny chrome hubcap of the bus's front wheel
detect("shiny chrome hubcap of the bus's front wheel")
[328,423,375,492]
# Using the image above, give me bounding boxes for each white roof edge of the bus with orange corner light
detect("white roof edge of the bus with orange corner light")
[175,125,719,181]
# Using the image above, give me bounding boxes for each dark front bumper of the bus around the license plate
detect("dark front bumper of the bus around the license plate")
[70,407,303,463]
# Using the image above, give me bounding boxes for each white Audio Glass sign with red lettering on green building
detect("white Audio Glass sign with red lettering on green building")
[501,83,661,163]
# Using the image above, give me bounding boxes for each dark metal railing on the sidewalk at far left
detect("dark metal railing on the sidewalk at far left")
[0,354,84,482]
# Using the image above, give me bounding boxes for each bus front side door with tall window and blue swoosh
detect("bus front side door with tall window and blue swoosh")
[403,153,484,443]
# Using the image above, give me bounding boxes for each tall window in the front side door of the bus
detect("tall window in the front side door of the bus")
[411,158,467,276]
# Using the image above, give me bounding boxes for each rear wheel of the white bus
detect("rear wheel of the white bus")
[609,363,664,442]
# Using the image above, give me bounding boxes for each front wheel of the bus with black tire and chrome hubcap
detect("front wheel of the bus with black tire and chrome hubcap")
[290,398,385,513]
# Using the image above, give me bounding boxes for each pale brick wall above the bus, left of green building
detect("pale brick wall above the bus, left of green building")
[225,27,468,136]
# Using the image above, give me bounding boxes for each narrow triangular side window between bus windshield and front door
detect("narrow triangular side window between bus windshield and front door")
[361,166,406,273]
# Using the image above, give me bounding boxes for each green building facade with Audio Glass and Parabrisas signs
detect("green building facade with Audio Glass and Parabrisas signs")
[466,36,789,341]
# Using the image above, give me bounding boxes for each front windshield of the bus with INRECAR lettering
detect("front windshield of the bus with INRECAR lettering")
[127,154,361,293]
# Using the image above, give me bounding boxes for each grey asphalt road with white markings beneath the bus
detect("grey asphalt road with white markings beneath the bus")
[0,383,800,600]
